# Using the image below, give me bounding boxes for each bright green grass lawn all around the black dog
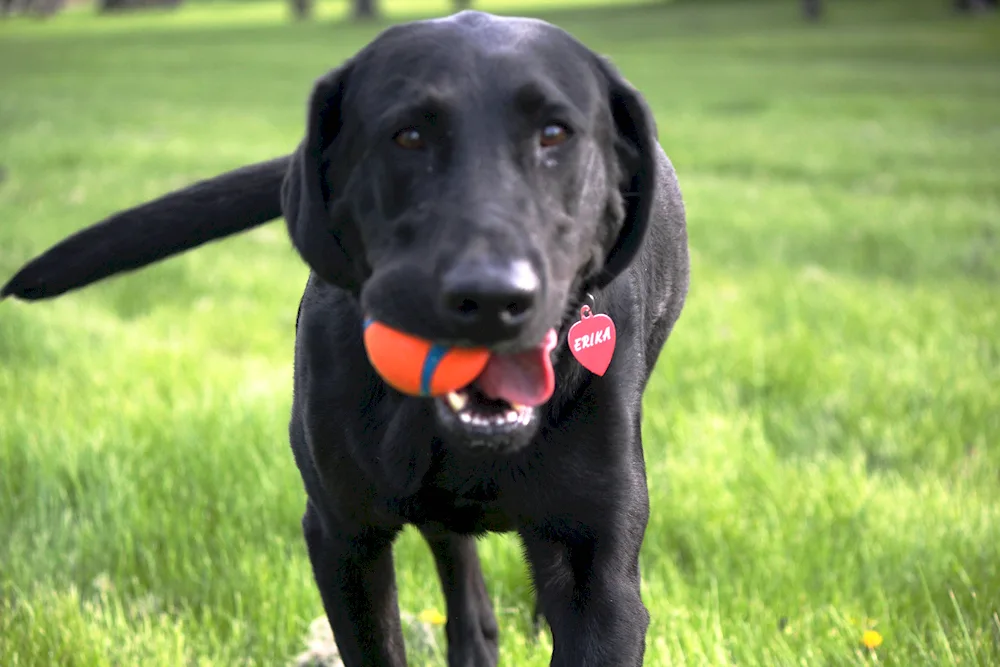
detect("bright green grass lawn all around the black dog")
[0,0,1000,667]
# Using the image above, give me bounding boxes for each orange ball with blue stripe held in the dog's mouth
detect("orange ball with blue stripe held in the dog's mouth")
[364,318,490,396]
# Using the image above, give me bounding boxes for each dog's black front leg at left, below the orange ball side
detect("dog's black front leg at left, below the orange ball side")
[302,502,406,667]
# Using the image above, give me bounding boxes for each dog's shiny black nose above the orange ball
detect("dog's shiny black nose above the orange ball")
[441,260,541,343]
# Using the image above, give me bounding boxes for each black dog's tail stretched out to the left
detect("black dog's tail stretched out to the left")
[0,155,290,301]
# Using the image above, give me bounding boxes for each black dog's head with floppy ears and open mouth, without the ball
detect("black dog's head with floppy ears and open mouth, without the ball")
[283,12,655,451]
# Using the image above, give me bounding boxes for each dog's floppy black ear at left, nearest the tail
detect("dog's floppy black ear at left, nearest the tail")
[281,62,367,293]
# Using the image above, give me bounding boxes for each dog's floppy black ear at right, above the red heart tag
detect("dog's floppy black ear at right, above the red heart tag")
[590,56,658,289]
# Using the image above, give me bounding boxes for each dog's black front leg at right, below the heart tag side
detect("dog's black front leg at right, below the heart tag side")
[521,484,649,667]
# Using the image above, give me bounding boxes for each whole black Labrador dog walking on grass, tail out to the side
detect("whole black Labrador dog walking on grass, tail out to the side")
[3,12,689,667]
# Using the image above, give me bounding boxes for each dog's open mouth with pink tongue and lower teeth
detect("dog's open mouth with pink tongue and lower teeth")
[435,329,558,438]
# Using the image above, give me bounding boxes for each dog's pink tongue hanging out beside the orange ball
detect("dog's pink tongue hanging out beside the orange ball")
[476,329,558,406]
